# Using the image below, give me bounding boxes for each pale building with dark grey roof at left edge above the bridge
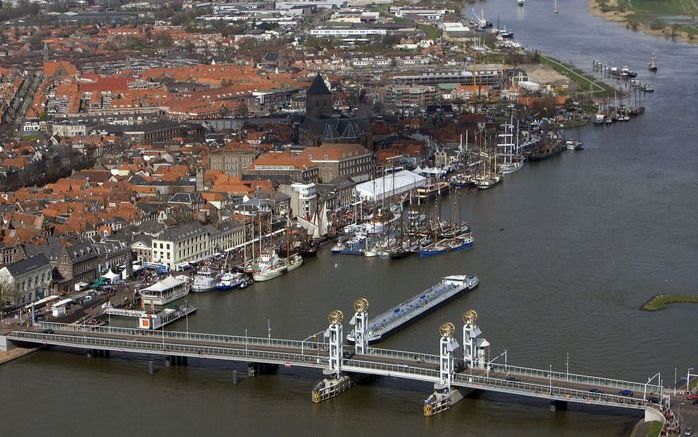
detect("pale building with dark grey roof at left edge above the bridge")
[0,254,51,305]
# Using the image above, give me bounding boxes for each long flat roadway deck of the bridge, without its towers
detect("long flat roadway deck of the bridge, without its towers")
[8,323,661,409]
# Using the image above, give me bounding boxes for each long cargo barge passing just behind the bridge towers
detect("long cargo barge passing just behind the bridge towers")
[347,275,480,343]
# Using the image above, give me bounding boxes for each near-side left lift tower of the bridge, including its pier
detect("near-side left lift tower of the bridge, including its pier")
[312,310,351,403]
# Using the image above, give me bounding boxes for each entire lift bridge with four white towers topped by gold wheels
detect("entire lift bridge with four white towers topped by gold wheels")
[7,299,670,422]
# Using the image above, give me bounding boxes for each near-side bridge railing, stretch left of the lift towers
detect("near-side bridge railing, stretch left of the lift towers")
[10,331,328,368]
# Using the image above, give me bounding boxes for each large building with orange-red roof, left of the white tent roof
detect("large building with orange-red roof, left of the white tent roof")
[303,143,373,183]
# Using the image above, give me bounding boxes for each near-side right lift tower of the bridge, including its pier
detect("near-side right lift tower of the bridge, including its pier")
[424,322,463,416]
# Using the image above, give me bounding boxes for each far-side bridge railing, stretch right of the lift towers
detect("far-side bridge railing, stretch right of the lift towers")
[490,363,661,393]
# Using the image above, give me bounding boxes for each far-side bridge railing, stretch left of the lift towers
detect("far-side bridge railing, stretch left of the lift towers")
[34,322,327,350]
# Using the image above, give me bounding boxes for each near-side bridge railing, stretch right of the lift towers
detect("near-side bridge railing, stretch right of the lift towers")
[453,373,648,408]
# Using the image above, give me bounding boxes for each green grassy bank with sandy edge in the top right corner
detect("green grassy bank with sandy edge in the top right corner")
[588,0,698,43]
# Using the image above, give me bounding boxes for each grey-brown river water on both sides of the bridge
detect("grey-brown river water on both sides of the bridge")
[0,0,698,436]
